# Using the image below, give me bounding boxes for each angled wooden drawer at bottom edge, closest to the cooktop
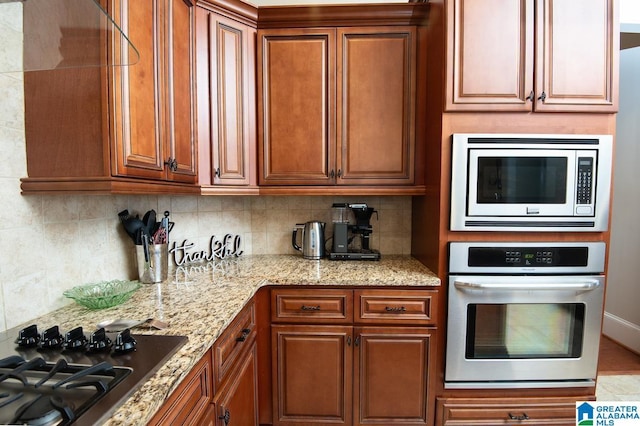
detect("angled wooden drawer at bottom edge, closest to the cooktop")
[149,351,213,426]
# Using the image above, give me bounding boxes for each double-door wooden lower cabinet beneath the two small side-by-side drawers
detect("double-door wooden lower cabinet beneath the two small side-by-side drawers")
[272,325,435,425]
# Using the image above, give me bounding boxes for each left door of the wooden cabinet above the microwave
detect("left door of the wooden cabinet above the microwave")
[445,0,532,111]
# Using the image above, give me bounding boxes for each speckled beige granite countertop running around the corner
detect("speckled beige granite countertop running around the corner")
[8,255,440,426]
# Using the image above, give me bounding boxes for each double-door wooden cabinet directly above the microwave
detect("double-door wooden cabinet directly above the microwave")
[445,0,618,112]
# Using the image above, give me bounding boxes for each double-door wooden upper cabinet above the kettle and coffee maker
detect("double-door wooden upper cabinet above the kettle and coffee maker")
[258,26,416,185]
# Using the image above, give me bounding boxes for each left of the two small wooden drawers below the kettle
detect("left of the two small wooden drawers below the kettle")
[271,289,353,324]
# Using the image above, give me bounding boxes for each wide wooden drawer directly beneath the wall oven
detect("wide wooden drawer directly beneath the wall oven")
[436,396,593,426]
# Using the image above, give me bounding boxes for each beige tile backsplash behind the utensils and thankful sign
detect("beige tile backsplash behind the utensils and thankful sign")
[0,3,411,332]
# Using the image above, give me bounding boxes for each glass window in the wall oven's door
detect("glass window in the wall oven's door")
[466,303,585,359]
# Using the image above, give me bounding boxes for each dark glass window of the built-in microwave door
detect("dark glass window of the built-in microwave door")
[477,157,567,204]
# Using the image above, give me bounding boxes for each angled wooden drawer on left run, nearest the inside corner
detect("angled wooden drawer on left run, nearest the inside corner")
[213,300,257,389]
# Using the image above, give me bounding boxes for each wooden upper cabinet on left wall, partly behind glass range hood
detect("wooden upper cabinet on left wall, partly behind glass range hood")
[22,0,200,194]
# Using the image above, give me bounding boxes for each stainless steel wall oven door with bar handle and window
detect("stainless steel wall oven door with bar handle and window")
[445,275,604,388]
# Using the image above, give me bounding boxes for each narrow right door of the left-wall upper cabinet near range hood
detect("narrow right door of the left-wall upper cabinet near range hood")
[160,0,196,183]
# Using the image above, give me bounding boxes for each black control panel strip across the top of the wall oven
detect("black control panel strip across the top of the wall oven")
[468,246,589,267]
